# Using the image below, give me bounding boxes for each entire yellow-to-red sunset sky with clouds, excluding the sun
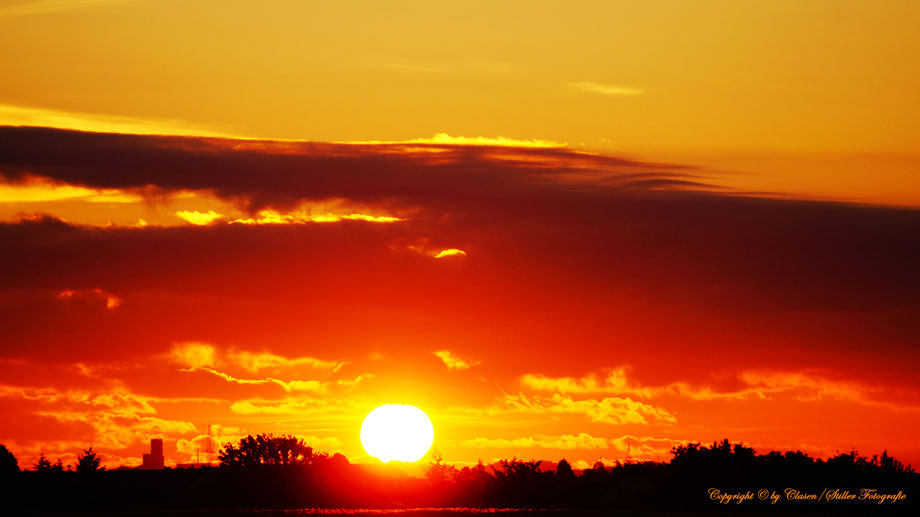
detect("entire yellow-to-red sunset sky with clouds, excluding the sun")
[0,0,920,468]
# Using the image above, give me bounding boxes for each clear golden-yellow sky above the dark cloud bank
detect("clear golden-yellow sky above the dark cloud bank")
[0,0,920,205]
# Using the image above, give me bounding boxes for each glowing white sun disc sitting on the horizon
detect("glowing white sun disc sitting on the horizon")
[361,404,434,463]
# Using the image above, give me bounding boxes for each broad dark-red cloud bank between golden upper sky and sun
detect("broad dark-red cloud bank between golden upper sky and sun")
[0,127,920,468]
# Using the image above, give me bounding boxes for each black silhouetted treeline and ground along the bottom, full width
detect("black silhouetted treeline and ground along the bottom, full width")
[0,434,920,514]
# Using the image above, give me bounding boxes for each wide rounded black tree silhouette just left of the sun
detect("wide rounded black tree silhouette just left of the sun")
[218,433,313,467]
